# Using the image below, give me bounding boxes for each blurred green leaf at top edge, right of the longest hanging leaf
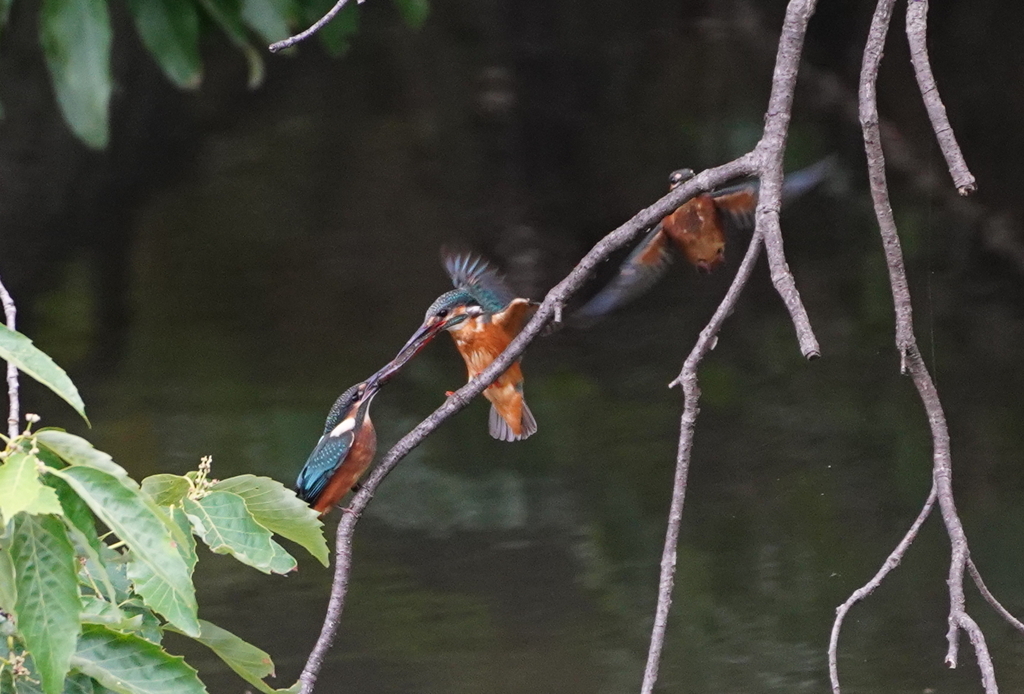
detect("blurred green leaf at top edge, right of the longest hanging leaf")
[122,0,203,89]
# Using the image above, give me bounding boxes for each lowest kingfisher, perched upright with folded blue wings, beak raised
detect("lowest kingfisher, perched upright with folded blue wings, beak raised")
[295,349,409,516]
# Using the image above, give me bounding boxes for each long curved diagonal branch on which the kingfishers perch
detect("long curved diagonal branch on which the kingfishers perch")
[299,154,755,694]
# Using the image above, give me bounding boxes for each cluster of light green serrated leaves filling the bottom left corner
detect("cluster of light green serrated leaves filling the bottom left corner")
[0,327,328,694]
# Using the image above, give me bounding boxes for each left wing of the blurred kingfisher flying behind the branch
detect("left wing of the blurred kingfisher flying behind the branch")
[573,224,672,324]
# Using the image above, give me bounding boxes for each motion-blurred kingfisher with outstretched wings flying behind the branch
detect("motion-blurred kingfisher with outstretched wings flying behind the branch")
[573,157,836,323]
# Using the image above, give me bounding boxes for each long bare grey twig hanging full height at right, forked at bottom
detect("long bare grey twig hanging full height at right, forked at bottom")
[860,0,998,694]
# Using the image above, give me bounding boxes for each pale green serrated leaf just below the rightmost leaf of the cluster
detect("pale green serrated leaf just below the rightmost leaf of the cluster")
[184,491,274,572]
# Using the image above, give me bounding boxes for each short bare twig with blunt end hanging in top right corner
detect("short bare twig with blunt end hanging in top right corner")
[906,0,978,196]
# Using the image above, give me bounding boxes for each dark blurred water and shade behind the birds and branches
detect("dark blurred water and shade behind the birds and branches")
[0,0,1024,694]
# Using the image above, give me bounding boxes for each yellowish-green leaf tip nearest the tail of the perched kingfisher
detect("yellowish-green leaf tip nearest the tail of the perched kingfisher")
[211,475,328,566]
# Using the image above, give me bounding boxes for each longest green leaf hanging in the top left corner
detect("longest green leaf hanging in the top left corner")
[39,0,112,149]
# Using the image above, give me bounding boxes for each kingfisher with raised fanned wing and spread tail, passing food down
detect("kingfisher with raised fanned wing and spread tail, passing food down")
[395,254,538,441]
